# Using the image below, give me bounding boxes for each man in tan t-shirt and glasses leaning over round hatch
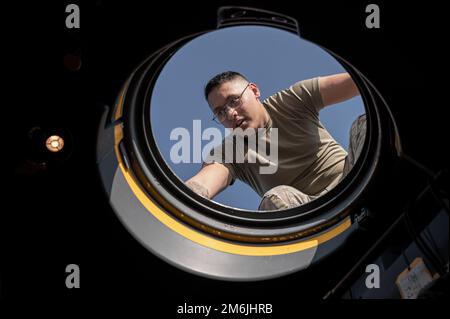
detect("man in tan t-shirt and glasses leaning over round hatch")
[186,71,366,211]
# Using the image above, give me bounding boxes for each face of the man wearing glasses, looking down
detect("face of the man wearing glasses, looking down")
[208,79,265,130]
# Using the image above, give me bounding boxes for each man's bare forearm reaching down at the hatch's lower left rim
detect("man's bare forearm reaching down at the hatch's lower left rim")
[185,163,231,199]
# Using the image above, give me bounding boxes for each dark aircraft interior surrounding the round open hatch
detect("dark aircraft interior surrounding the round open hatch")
[6,0,449,308]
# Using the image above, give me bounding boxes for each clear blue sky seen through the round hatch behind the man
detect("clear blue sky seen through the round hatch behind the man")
[150,26,364,210]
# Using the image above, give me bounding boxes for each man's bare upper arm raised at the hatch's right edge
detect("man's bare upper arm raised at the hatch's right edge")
[319,73,359,107]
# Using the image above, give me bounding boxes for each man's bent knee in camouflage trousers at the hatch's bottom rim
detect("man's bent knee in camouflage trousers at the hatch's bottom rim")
[258,185,313,210]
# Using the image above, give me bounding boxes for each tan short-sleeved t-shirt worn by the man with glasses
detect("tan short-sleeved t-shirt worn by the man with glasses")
[205,78,347,196]
